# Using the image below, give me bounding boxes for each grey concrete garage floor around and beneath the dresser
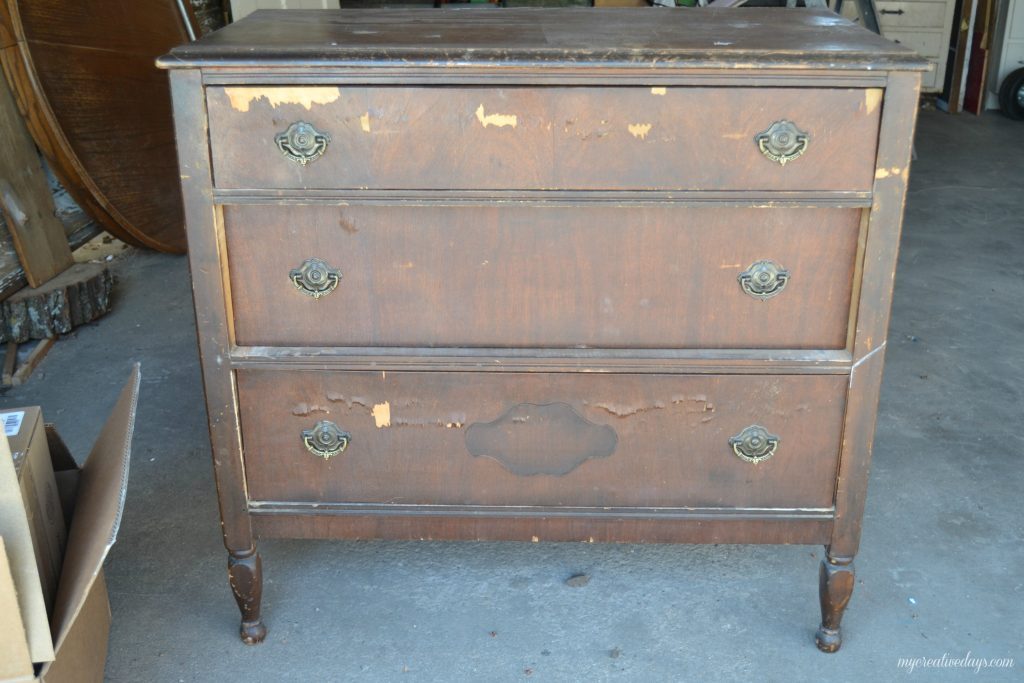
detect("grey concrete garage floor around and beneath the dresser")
[0,111,1024,682]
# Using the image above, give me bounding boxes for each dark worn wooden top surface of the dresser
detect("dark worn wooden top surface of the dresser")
[158,7,928,70]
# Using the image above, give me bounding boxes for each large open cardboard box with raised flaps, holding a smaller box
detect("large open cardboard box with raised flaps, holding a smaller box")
[0,365,140,683]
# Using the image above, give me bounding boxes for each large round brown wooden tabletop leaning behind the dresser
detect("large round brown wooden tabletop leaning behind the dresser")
[0,0,191,252]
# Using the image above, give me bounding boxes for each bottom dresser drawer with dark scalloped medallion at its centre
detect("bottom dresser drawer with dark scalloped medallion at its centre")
[238,370,846,508]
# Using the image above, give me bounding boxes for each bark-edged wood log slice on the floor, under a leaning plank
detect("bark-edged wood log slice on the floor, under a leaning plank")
[0,263,114,343]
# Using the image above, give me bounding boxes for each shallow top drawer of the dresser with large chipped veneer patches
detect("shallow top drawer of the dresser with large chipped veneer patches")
[207,86,882,191]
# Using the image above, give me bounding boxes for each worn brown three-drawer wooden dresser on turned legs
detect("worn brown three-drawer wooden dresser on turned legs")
[159,8,927,651]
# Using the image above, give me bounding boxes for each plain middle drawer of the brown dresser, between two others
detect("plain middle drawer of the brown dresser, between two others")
[224,204,861,349]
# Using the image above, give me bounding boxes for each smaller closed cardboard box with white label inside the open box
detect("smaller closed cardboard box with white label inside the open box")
[0,405,68,614]
